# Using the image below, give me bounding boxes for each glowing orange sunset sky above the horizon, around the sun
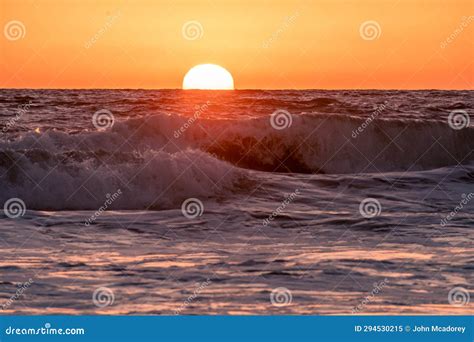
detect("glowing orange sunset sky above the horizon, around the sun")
[0,0,474,89]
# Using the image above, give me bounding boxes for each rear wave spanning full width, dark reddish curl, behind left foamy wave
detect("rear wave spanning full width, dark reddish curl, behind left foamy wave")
[0,114,474,174]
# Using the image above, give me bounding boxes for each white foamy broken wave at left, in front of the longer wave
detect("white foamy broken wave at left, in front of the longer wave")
[0,150,242,210]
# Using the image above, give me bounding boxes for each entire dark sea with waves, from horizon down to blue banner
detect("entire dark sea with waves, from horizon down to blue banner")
[0,90,474,314]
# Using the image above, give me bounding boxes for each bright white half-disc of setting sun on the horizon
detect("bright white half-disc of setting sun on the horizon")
[183,64,234,90]
